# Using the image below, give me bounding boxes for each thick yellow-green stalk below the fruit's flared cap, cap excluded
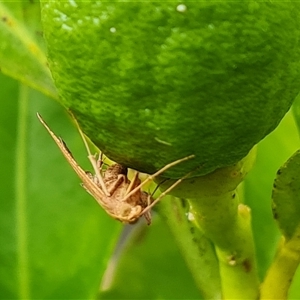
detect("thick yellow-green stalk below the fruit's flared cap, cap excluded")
[189,192,259,299]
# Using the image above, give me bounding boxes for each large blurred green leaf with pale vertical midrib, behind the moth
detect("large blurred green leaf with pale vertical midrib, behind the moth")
[0,75,121,299]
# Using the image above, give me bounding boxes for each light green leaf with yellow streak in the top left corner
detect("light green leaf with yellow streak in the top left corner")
[0,2,57,98]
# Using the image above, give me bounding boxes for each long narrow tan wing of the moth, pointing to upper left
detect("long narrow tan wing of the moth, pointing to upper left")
[37,114,116,213]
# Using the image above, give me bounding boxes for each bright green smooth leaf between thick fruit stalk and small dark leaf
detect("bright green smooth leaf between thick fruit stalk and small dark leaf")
[243,113,299,279]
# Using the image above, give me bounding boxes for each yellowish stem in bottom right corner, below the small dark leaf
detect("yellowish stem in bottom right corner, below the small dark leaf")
[261,228,300,300]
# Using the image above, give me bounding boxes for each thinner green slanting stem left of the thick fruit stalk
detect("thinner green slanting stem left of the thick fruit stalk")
[159,196,221,299]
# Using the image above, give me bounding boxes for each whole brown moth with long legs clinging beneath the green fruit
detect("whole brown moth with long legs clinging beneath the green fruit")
[37,114,194,225]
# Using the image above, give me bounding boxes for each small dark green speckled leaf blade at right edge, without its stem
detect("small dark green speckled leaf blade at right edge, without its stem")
[272,150,300,239]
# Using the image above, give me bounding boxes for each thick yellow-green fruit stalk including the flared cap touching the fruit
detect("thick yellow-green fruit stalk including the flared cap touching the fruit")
[161,150,259,299]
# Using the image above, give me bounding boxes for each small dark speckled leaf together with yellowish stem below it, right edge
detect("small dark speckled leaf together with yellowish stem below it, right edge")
[261,144,300,299]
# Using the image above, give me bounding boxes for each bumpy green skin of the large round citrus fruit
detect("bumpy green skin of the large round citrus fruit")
[42,0,300,178]
